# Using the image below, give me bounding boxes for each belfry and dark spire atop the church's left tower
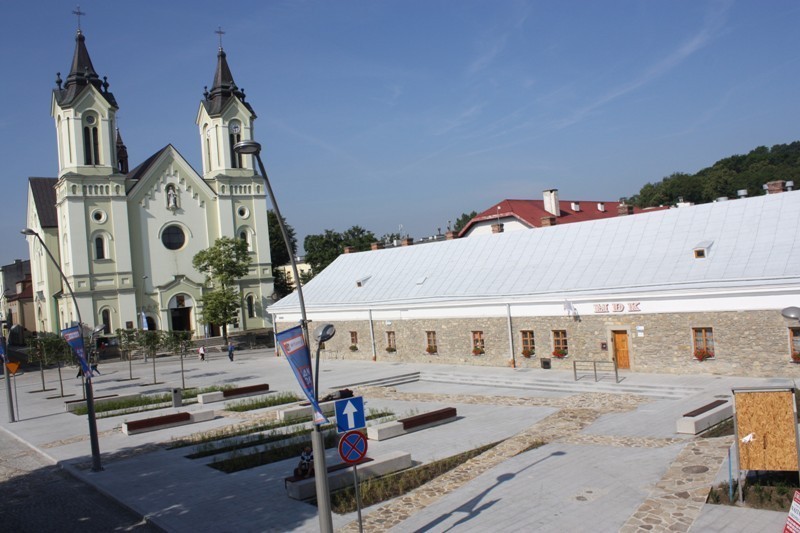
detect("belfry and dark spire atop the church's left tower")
[51,29,119,178]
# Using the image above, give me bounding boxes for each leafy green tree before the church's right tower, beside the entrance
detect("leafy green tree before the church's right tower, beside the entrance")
[192,237,251,342]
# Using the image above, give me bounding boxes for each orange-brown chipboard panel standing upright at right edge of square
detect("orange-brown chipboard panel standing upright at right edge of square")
[734,391,798,470]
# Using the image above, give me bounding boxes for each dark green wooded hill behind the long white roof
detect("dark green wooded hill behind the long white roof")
[628,141,800,207]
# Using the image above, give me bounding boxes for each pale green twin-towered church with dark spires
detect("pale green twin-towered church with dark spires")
[26,29,273,337]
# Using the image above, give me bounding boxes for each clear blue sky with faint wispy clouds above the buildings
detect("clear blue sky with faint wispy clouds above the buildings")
[0,0,800,264]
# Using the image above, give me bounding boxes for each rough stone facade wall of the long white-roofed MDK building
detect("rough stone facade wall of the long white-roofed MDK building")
[278,311,800,377]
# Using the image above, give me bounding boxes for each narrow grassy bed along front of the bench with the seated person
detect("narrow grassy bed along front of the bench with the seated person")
[331,442,499,514]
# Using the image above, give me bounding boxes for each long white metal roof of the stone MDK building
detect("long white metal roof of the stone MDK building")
[270,191,800,312]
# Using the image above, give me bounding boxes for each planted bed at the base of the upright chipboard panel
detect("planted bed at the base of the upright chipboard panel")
[707,472,800,512]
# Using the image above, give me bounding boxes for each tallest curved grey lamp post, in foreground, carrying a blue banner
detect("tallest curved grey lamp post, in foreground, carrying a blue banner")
[233,141,333,533]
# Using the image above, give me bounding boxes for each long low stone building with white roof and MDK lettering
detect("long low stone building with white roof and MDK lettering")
[271,182,800,376]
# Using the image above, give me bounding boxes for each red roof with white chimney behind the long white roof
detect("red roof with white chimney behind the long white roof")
[458,200,669,237]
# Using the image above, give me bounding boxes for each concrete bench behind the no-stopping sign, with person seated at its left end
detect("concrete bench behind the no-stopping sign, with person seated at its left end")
[285,451,411,500]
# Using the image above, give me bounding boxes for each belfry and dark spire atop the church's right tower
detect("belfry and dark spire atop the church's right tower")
[197,45,256,180]
